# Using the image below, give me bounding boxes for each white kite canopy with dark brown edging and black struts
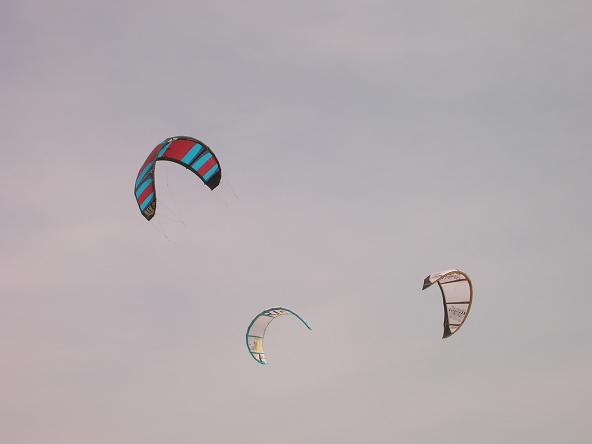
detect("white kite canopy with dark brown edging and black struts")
[422,270,473,339]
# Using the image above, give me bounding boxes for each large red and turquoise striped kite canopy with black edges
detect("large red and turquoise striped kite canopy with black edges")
[134,136,222,220]
